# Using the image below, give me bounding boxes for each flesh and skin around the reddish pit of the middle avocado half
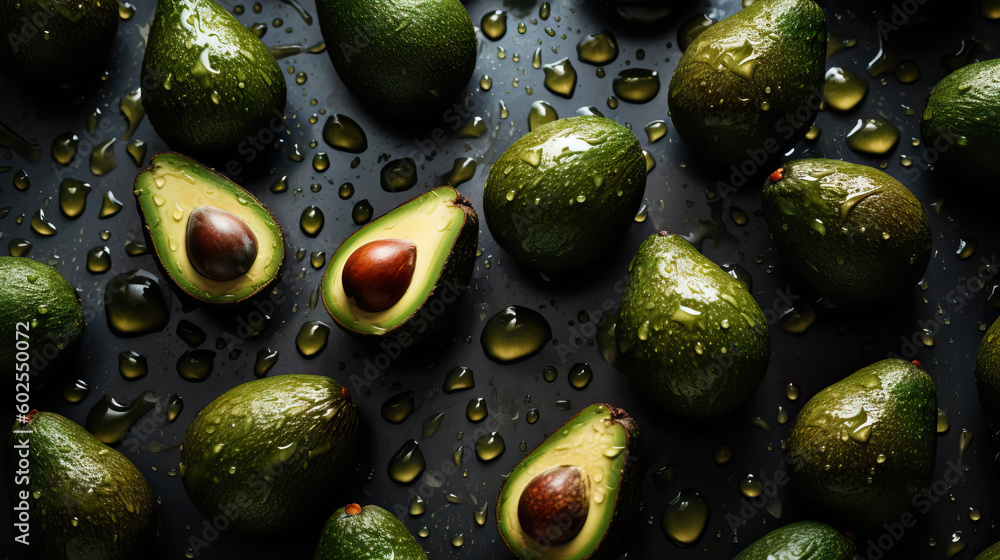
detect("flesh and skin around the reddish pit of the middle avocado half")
[323,187,479,347]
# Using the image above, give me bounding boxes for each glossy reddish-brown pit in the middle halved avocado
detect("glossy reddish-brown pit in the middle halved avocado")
[342,238,417,313]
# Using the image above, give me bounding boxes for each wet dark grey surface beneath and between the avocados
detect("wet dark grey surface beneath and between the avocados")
[0,0,1000,559]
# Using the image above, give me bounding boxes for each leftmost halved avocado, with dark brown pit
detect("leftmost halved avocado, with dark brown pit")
[134,152,285,304]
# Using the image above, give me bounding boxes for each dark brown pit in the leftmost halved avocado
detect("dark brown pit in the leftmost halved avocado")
[185,206,257,282]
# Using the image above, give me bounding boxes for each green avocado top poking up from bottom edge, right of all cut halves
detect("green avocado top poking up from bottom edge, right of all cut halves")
[733,521,857,560]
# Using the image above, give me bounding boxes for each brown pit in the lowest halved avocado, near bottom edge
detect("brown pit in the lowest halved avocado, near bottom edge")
[517,465,590,546]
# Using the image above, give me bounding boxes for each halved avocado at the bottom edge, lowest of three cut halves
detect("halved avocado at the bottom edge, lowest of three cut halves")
[497,404,641,560]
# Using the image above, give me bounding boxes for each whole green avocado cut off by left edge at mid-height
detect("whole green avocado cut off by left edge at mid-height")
[0,257,84,388]
